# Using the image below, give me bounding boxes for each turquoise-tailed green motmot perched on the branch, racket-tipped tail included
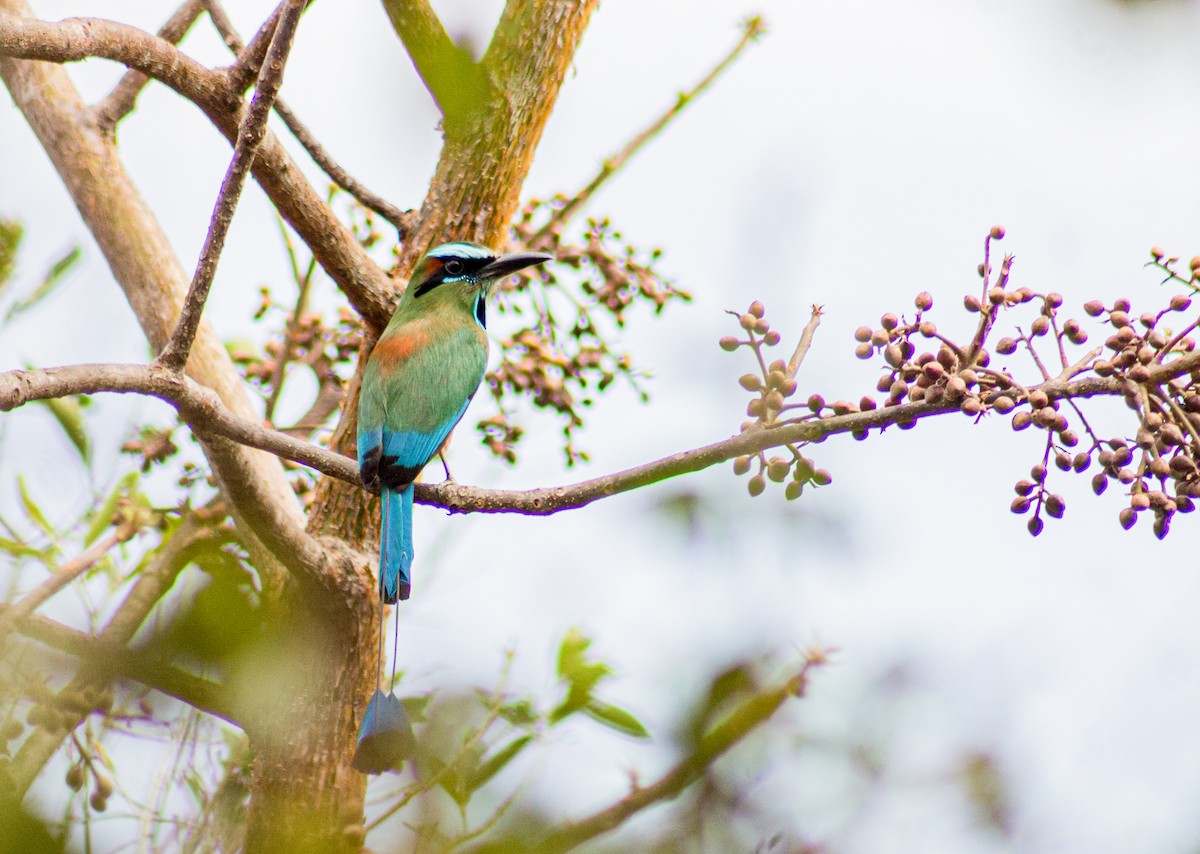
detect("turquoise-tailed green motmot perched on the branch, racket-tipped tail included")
[354,242,551,774]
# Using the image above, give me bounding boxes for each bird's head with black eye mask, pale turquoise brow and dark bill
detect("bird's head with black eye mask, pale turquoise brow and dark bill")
[403,242,553,326]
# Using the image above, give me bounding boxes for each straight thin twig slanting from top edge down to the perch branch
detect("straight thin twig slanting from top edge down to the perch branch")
[158,0,305,371]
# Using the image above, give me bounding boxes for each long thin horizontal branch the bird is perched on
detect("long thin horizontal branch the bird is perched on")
[0,349,1200,516]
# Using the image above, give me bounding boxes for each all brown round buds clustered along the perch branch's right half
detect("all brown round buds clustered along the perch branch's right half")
[720,227,1200,539]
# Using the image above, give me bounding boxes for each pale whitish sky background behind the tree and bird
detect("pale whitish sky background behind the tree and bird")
[0,0,1200,854]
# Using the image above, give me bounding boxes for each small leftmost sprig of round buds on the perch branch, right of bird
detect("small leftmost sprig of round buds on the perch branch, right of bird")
[719,300,833,500]
